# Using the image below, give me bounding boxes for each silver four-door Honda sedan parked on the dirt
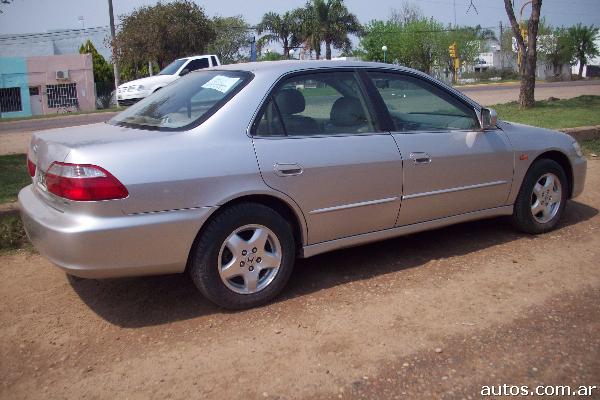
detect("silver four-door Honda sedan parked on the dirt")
[19,61,586,309]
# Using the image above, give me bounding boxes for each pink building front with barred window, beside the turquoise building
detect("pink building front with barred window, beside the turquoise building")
[27,54,96,115]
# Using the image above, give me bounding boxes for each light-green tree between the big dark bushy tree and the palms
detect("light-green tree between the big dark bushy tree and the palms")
[208,15,252,64]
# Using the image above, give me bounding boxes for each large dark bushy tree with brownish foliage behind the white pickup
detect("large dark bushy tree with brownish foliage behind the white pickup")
[113,0,216,75]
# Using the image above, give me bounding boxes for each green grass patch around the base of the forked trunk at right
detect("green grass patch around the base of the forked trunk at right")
[492,96,600,129]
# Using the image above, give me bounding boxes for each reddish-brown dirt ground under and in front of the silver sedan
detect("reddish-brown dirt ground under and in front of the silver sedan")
[0,161,600,400]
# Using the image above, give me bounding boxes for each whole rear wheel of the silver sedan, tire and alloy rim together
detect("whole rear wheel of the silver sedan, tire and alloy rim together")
[189,203,296,310]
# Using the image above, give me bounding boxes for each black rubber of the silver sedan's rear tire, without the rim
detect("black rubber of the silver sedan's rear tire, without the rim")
[189,203,296,310]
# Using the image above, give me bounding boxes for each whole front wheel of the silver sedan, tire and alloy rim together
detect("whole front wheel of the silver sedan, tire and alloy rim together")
[512,159,569,235]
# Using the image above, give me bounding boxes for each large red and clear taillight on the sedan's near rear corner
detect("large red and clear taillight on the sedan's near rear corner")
[45,162,129,201]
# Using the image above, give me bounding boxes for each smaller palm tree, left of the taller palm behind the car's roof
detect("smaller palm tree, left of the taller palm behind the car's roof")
[256,11,299,57]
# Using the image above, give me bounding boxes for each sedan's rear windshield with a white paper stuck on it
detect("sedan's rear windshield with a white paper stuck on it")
[109,71,252,131]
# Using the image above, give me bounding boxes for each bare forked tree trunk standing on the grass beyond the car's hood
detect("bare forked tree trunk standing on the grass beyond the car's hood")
[504,0,542,108]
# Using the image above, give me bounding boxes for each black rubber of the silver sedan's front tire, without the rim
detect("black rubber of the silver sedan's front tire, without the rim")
[512,159,569,235]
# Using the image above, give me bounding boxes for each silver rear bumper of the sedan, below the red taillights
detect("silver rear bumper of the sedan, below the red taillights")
[19,185,214,278]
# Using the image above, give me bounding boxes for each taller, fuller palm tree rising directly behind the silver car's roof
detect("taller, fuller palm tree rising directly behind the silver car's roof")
[307,0,362,60]
